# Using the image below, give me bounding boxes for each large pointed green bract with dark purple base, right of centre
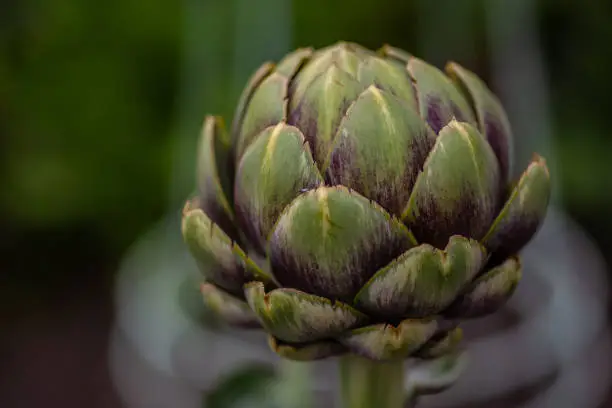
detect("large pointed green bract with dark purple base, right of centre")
[404,120,500,248]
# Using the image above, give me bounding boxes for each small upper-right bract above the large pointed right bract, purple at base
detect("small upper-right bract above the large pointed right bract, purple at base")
[407,57,476,133]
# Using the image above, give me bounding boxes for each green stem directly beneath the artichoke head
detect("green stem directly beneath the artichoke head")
[340,355,405,408]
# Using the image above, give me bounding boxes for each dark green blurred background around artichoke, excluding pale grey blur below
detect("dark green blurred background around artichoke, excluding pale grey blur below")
[0,0,612,408]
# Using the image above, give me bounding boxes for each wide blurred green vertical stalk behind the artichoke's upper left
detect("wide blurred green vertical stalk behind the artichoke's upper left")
[169,0,293,206]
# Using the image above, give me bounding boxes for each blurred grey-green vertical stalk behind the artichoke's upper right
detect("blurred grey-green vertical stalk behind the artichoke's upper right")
[482,0,561,202]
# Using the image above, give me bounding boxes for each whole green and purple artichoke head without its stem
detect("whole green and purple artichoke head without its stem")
[182,43,550,360]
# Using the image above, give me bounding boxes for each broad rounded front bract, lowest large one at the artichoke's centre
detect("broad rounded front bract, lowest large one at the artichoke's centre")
[270,186,412,302]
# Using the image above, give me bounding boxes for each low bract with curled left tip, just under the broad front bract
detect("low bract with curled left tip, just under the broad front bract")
[244,282,367,343]
